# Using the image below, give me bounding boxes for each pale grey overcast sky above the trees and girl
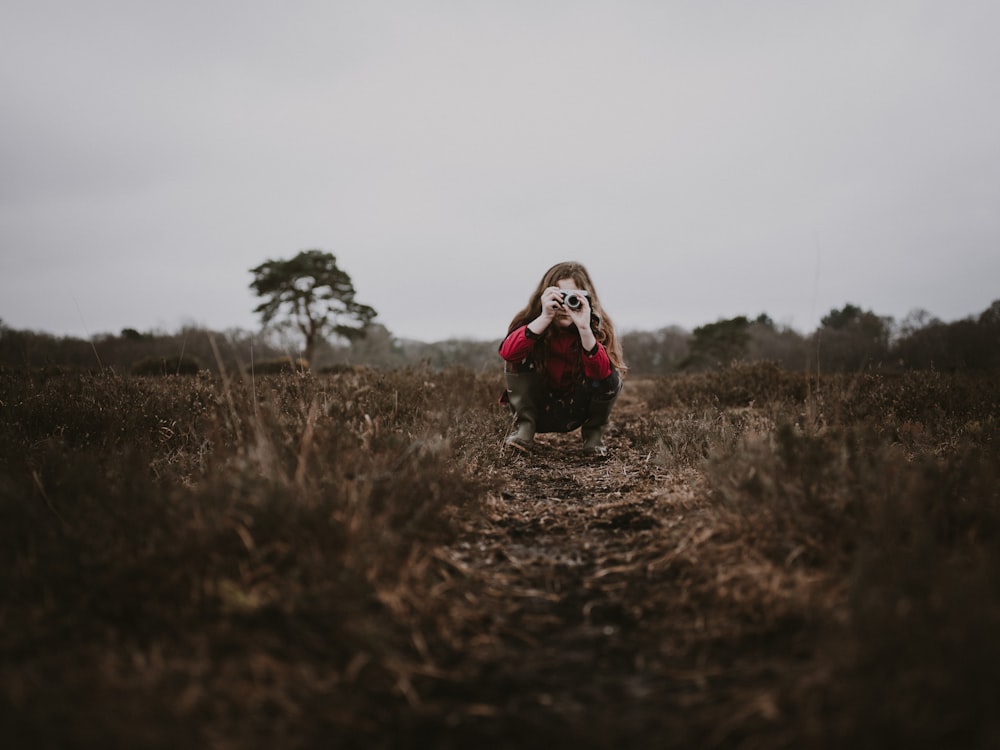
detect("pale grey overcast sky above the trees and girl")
[0,0,1000,341]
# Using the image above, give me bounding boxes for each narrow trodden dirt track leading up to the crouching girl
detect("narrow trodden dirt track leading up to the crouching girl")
[422,390,736,747]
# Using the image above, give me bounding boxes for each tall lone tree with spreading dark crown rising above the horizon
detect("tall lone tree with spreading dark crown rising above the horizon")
[250,250,378,363]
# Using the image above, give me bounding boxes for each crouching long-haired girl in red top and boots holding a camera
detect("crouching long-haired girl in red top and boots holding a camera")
[500,262,627,456]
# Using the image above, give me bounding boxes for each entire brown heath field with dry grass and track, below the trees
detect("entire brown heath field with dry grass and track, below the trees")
[0,364,1000,750]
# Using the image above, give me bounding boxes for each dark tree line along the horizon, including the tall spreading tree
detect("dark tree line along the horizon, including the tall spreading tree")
[0,250,1000,375]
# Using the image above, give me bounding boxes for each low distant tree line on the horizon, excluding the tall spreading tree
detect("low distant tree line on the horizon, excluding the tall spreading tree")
[0,300,1000,375]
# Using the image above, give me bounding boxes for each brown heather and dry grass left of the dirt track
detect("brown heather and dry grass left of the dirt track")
[0,364,494,747]
